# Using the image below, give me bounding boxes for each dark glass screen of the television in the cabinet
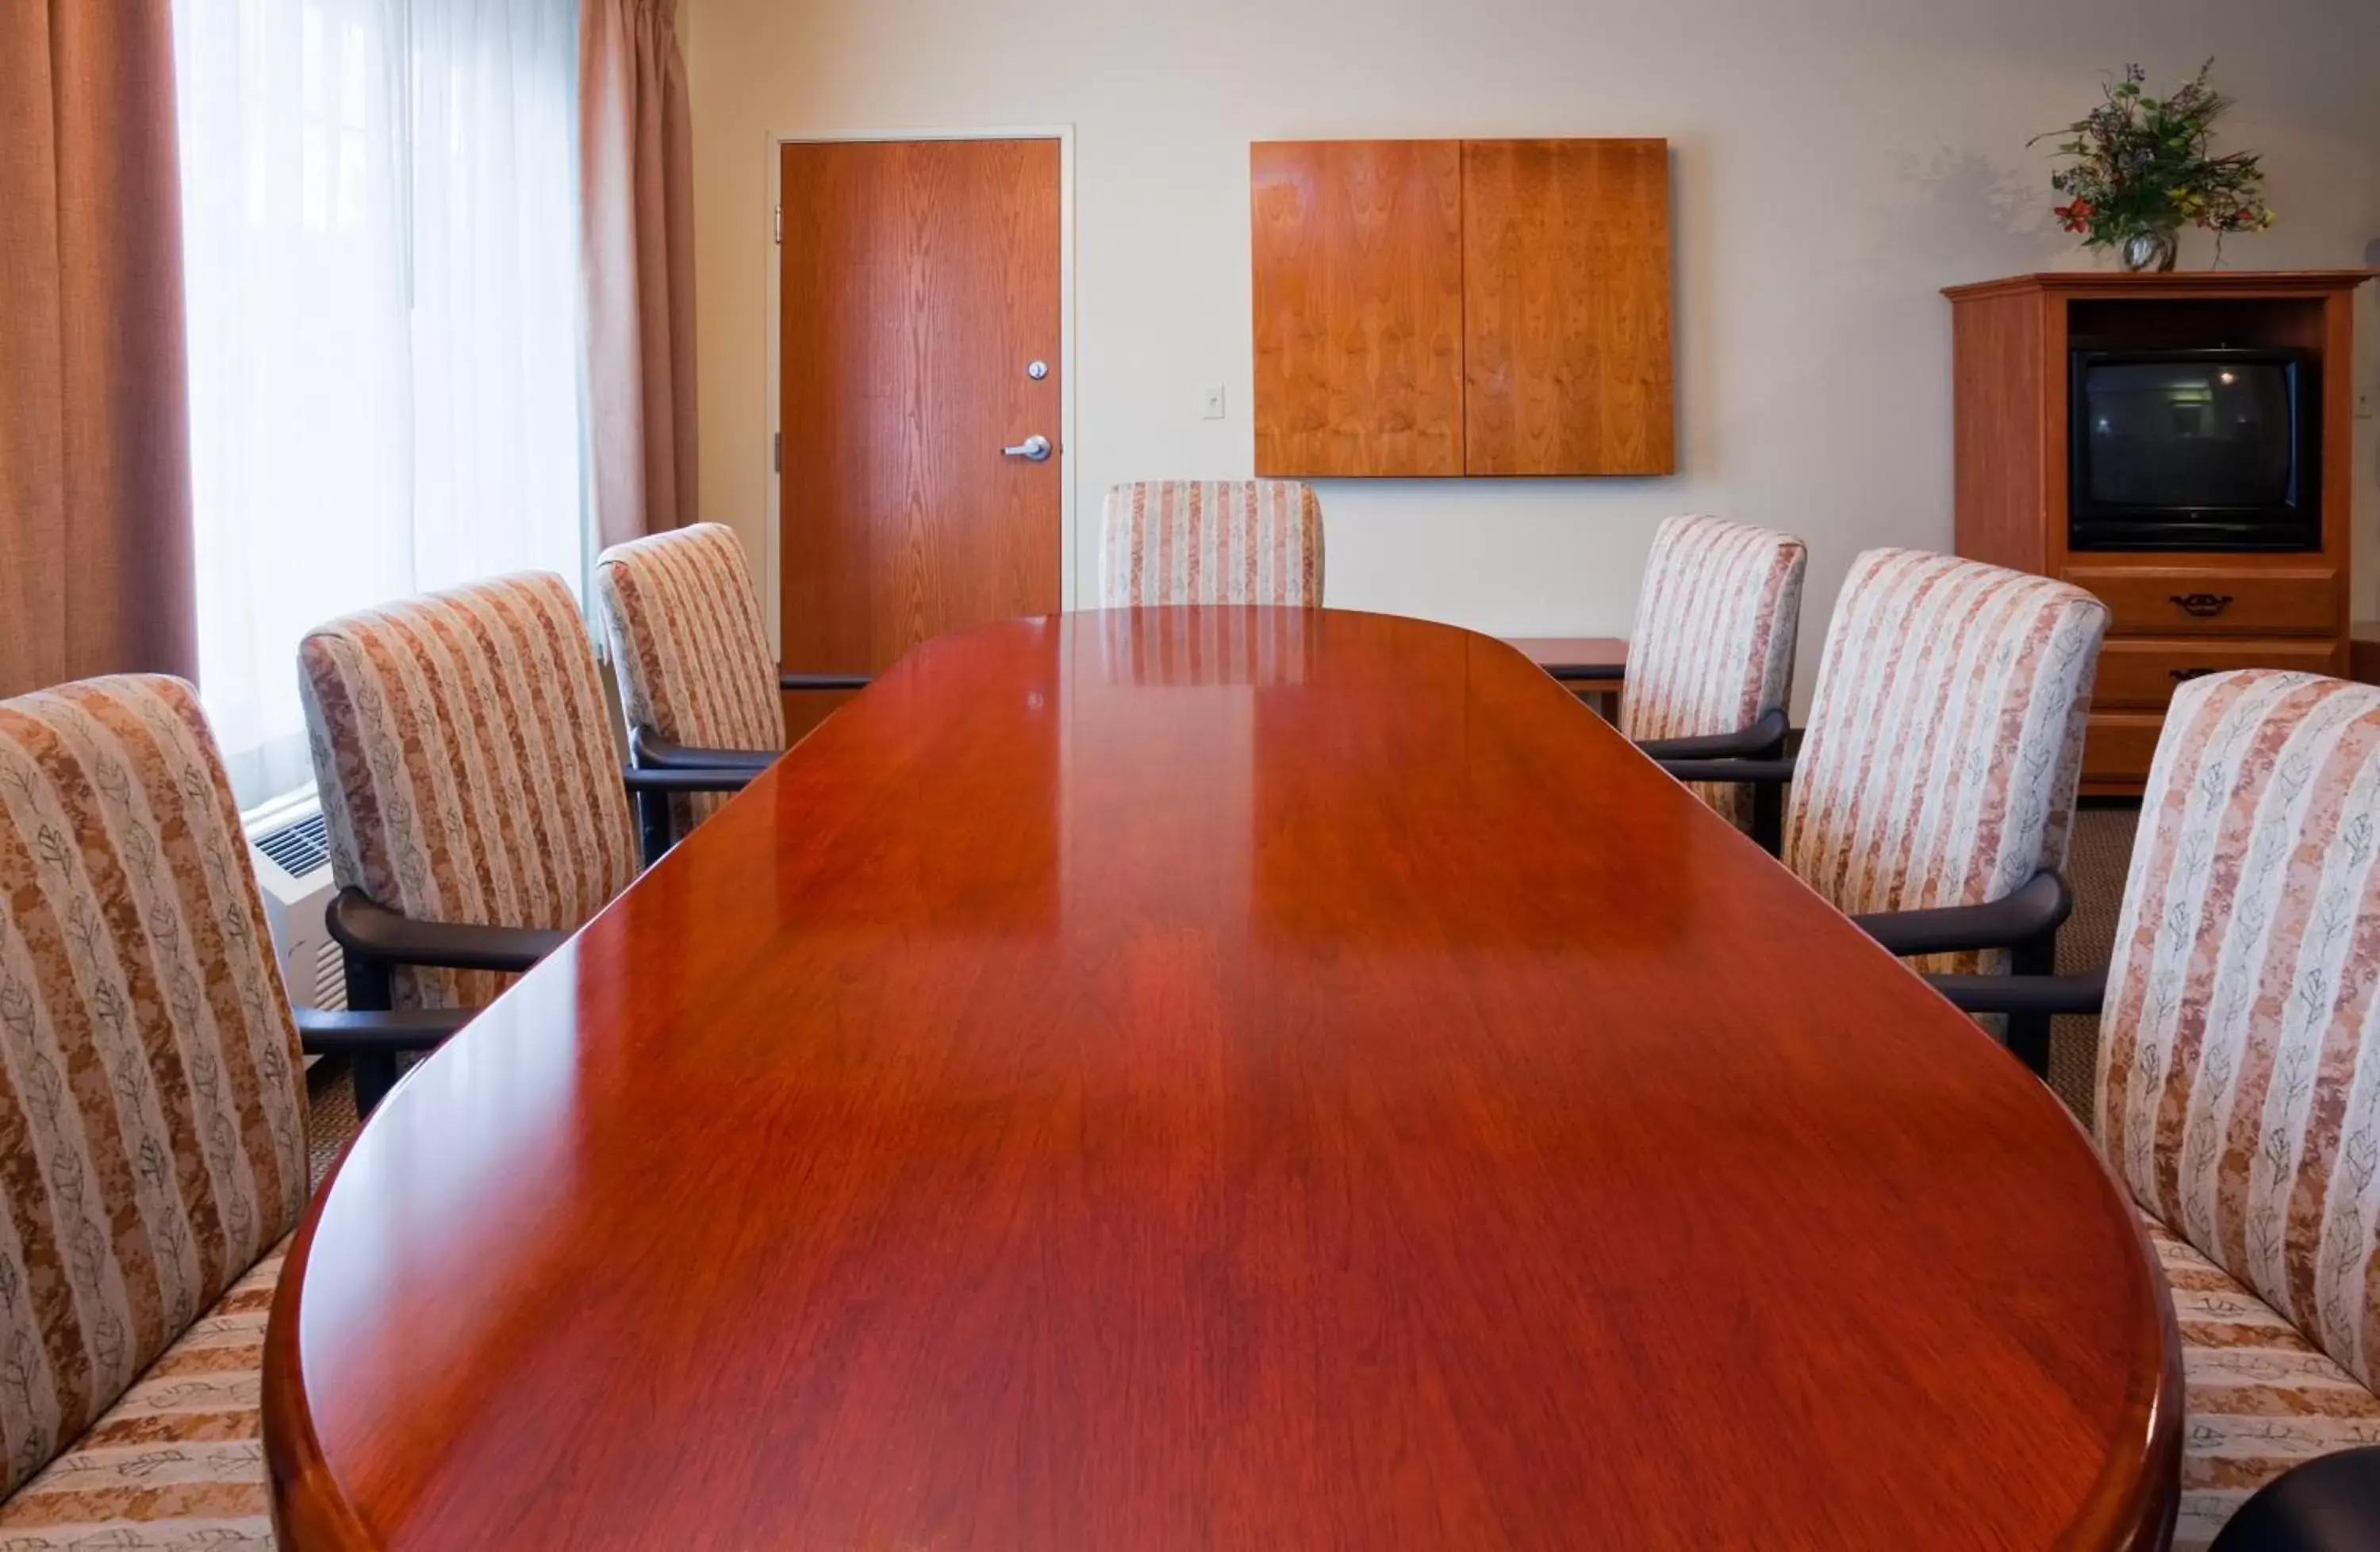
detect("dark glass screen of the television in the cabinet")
[2082,359,2297,507]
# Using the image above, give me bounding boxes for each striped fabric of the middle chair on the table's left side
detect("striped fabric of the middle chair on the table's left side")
[298,571,638,1007]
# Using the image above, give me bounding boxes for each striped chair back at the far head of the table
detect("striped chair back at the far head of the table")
[1100,478,1323,609]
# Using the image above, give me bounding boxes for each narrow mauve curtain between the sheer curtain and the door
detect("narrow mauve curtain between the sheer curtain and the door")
[578,0,700,545]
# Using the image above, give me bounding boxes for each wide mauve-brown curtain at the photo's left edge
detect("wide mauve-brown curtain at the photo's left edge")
[0,0,198,695]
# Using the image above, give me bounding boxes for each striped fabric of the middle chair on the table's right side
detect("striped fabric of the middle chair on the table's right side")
[1785,550,2106,974]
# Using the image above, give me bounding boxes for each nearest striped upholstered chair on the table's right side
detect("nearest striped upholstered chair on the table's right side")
[1935,669,2380,1552]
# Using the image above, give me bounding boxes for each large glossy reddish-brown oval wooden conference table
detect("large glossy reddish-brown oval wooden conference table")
[264,609,2180,1552]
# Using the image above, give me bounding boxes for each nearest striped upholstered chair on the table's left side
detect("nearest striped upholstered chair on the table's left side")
[0,678,452,1547]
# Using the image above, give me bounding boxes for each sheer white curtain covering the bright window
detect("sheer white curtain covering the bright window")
[174,0,585,802]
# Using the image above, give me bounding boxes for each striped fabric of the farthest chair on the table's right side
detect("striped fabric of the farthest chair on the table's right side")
[1621,517,1809,828]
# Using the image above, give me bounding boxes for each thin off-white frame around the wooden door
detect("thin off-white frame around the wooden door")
[764,124,1081,662]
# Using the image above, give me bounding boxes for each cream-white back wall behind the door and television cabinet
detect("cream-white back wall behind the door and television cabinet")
[688,0,2380,693]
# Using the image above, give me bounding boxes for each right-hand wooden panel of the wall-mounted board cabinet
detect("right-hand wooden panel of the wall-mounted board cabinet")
[1464,140,1678,474]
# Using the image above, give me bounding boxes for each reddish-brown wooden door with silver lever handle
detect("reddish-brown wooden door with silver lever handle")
[778,140,1064,736]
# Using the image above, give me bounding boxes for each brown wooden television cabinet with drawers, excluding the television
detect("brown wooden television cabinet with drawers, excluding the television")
[1942,269,2368,795]
